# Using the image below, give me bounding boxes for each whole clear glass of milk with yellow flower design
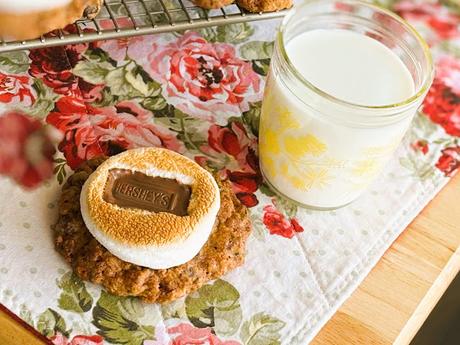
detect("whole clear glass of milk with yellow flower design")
[259,0,433,209]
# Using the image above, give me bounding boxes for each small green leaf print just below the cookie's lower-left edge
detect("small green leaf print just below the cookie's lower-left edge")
[57,272,93,313]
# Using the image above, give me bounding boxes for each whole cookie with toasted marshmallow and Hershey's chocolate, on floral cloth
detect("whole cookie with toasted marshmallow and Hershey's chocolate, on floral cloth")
[54,148,251,303]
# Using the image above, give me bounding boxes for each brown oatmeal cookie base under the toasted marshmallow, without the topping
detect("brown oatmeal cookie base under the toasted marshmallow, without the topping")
[54,158,251,303]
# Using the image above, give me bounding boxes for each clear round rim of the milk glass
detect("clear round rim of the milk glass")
[277,0,434,110]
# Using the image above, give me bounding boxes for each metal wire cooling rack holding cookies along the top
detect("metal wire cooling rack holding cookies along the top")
[0,0,286,52]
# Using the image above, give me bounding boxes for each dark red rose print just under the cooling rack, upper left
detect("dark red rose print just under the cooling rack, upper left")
[29,44,103,101]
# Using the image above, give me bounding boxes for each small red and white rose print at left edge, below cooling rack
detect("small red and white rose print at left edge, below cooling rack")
[0,72,35,106]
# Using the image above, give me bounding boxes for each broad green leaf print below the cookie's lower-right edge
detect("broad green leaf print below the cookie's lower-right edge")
[185,279,242,336]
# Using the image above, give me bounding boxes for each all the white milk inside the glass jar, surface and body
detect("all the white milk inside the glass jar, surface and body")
[259,29,416,209]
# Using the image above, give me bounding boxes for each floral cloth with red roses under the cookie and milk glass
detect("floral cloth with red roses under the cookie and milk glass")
[0,0,460,345]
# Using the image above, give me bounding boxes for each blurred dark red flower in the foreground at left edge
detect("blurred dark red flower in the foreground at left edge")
[0,112,55,188]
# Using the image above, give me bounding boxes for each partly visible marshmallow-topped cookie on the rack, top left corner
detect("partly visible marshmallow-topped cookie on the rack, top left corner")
[0,0,104,40]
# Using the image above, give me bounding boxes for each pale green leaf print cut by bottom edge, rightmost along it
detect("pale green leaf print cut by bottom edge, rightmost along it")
[240,313,286,345]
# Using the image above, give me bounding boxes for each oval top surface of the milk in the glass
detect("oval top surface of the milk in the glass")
[286,30,415,106]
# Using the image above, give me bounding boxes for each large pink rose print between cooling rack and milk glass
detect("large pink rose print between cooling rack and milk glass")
[149,32,263,124]
